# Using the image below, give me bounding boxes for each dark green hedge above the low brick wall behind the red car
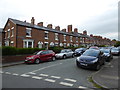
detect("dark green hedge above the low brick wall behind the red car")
[0,46,45,56]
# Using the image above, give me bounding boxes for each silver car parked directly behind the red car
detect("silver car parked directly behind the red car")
[55,49,75,59]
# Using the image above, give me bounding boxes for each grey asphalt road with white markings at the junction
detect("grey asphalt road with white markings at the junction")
[1,57,118,88]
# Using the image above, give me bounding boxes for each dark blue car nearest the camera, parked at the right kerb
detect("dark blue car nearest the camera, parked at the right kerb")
[76,49,105,70]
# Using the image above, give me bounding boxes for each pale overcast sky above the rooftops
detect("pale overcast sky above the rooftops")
[0,0,119,39]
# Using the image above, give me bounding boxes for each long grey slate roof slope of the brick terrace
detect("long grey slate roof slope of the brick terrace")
[9,18,89,37]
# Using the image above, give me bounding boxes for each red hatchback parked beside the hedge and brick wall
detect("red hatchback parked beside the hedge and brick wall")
[25,50,56,64]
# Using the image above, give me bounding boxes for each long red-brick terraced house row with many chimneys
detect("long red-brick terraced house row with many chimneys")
[3,17,114,48]
